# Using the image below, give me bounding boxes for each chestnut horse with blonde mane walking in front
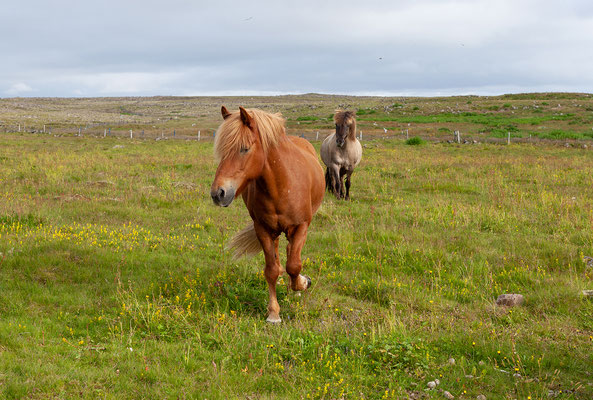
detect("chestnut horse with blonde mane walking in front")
[210,106,325,323]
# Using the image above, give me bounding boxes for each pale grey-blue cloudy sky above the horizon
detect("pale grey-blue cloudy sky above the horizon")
[0,0,593,98]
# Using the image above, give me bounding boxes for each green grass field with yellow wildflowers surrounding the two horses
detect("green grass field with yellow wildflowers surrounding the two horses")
[0,96,593,399]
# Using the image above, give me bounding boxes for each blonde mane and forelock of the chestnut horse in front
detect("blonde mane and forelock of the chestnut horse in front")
[214,109,286,160]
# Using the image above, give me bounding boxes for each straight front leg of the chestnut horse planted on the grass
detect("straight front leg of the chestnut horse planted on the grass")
[255,225,282,323]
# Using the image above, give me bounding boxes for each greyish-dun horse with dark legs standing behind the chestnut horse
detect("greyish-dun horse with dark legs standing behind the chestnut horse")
[321,111,362,200]
